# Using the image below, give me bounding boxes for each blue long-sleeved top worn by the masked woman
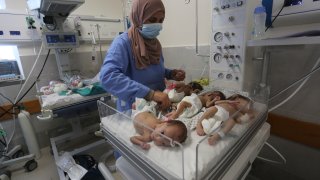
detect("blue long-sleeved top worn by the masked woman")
[100,32,171,111]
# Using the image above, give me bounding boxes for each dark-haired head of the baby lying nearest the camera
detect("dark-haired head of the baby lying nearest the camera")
[151,120,188,146]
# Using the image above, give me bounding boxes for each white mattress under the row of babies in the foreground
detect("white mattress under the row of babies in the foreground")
[101,102,265,179]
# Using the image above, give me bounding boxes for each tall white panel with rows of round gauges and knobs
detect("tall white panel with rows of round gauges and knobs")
[210,0,258,90]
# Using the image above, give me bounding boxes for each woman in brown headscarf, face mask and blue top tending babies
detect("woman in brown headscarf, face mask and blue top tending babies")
[100,0,185,111]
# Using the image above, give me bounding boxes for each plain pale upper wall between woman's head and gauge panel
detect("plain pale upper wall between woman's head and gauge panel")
[159,0,211,47]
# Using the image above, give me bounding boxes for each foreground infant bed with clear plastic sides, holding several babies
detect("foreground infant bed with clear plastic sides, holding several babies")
[98,89,270,179]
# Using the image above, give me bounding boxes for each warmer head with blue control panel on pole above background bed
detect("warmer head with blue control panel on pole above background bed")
[27,0,85,79]
